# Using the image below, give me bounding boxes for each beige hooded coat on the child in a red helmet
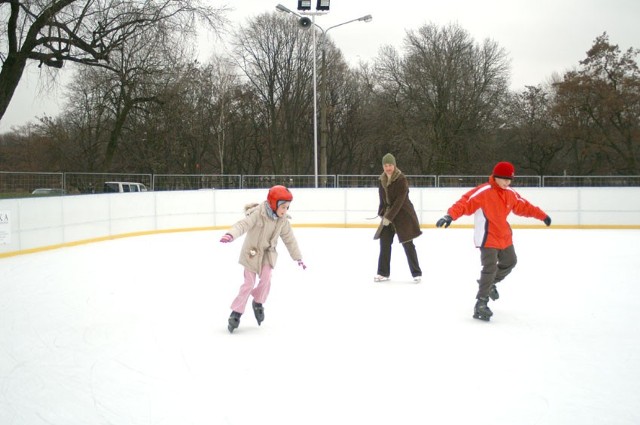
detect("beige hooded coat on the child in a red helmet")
[227,201,302,273]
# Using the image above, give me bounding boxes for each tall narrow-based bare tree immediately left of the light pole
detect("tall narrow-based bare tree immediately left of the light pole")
[235,12,313,174]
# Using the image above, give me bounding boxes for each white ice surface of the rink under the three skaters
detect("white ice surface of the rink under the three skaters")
[0,227,640,425]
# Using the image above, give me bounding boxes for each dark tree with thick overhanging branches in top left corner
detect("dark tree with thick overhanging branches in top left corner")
[0,0,226,124]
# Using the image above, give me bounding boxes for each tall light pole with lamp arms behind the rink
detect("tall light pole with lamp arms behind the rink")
[276,1,373,187]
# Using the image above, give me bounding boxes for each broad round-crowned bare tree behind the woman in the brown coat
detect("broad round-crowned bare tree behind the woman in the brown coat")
[376,24,509,173]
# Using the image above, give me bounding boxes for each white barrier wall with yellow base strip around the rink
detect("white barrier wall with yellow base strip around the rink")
[0,187,640,258]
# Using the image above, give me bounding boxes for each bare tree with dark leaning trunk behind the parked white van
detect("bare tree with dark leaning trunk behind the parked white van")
[37,18,190,171]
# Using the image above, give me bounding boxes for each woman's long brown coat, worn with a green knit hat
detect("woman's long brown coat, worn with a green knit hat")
[378,168,422,243]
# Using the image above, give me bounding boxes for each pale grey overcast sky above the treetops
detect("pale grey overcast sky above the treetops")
[0,0,640,132]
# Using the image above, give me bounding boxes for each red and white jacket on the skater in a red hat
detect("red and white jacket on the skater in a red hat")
[447,176,547,249]
